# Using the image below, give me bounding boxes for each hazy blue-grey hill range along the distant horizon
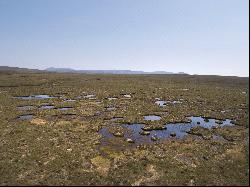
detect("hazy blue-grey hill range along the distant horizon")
[45,67,186,74]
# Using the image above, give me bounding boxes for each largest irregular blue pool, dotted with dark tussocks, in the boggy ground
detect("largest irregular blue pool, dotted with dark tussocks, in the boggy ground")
[99,116,234,145]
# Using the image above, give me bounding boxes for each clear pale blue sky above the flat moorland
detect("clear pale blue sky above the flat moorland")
[0,0,249,77]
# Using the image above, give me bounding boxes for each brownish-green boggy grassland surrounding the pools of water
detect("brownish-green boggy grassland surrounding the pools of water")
[0,73,249,185]
